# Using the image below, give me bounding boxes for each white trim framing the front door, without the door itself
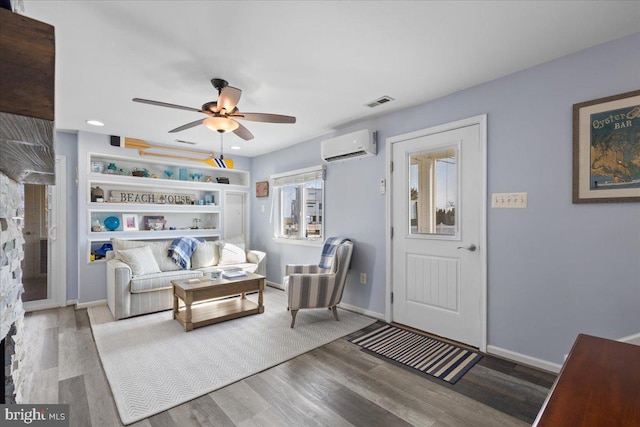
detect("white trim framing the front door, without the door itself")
[385,114,487,352]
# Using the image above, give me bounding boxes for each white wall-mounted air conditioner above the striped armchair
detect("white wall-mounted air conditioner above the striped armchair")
[320,129,378,163]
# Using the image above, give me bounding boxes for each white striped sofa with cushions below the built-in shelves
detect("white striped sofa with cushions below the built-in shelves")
[107,239,266,319]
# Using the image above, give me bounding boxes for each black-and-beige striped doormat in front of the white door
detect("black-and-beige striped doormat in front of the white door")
[350,325,482,384]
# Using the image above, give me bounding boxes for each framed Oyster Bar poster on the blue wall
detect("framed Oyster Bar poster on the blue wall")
[573,90,640,203]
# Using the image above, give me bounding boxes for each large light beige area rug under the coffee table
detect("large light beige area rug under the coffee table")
[91,289,375,424]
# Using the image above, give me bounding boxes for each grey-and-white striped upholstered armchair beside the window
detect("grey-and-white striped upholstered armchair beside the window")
[284,237,353,328]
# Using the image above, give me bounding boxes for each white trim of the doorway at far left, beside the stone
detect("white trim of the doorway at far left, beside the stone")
[24,156,67,311]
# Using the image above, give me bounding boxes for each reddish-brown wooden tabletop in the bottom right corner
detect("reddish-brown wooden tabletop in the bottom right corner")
[533,334,640,427]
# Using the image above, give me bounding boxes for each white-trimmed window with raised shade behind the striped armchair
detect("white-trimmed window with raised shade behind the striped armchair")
[271,166,324,242]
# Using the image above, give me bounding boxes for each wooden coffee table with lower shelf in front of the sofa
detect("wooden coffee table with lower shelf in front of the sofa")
[171,273,265,332]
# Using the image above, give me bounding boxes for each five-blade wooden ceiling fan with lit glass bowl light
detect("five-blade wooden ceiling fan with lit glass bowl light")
[133,78,296,141]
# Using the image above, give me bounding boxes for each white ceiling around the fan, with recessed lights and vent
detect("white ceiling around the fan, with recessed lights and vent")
[24,0,640,156]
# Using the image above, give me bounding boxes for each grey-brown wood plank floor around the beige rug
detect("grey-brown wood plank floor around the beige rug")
[17,290,555,427]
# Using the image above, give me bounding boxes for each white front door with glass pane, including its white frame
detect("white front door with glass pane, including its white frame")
[389,116,486,351]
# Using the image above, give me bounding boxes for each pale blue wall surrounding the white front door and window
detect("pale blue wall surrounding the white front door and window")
[251,34,640,364]
